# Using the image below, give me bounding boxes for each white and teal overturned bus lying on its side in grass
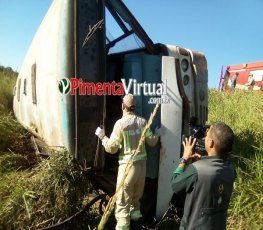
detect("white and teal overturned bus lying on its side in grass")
[14,0,208,226]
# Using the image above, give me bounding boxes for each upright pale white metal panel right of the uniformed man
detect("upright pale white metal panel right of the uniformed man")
[156,57,182,219]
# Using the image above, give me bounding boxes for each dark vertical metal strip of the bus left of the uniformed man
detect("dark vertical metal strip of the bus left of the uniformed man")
[75,0,106,162]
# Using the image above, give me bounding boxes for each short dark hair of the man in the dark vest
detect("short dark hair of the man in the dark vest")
[210,121,235,158]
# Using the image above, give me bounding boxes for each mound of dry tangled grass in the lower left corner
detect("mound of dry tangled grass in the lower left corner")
[0,151,96,229]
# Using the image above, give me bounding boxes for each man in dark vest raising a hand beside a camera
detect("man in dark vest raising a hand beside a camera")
[172,122,235,230]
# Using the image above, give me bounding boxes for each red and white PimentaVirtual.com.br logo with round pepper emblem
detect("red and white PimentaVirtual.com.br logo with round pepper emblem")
[58,78,170,104]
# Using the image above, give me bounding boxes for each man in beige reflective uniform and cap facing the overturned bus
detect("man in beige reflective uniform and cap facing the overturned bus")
[95,94,163,229]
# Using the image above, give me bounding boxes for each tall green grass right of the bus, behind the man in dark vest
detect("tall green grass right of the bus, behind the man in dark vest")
[208,91,263,230]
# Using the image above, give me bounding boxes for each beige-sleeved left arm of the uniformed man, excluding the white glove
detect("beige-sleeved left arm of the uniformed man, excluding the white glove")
[102,122,122,154]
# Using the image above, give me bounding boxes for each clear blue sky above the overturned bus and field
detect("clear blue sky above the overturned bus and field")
[0,0,263,88]
